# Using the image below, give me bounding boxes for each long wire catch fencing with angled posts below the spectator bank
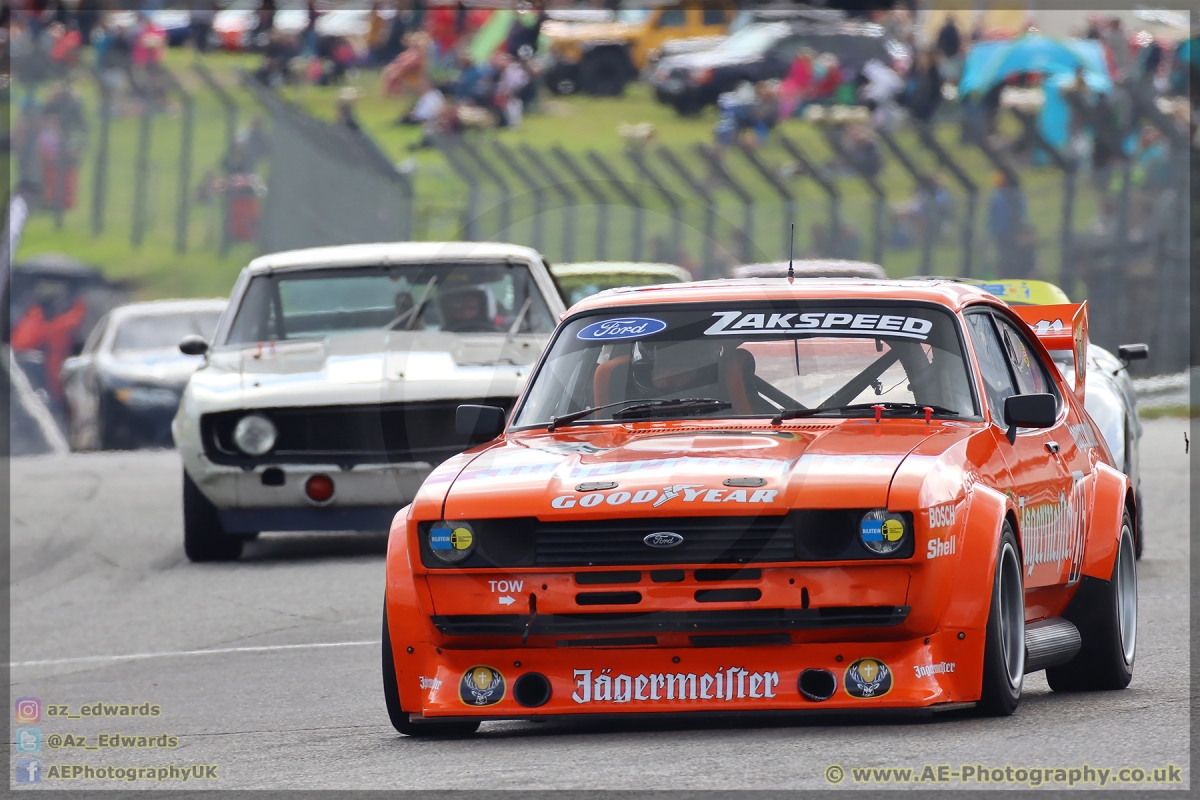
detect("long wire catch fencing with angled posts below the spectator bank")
[11,57,1192,374]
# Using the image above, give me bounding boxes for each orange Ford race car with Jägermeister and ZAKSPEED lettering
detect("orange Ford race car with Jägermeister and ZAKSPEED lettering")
[383,279,1136,735]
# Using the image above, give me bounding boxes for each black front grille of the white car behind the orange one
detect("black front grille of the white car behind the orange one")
[200,397,514,465]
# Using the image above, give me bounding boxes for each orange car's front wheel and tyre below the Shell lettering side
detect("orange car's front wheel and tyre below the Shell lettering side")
[977,522,1025,717]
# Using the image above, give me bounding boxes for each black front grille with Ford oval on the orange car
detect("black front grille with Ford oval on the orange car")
[419,509,913,570]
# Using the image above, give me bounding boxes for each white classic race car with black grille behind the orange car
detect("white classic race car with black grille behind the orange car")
[172,242,565,561]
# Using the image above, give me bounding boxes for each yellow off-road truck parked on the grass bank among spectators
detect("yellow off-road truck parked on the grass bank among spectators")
[541,4,733,97]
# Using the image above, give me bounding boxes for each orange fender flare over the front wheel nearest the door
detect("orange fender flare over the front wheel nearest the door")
[941,483,1015,630]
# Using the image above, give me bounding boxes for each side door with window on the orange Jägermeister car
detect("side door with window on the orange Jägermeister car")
[966,312,1084,592]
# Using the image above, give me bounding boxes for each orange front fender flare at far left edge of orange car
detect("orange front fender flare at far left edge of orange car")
[384,504,428,710]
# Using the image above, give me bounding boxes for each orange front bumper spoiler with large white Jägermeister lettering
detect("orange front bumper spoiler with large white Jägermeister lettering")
[392,631,983,720]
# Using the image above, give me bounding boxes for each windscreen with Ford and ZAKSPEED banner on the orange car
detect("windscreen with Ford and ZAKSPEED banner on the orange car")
[514,302,978,427]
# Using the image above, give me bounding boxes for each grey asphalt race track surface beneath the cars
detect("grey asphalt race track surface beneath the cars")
[8,419,1189,789]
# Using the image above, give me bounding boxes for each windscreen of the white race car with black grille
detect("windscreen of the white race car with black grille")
[224,261,554,344]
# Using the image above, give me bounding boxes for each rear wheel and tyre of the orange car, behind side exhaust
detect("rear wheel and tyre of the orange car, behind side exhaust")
[1046,510,1138,692]
